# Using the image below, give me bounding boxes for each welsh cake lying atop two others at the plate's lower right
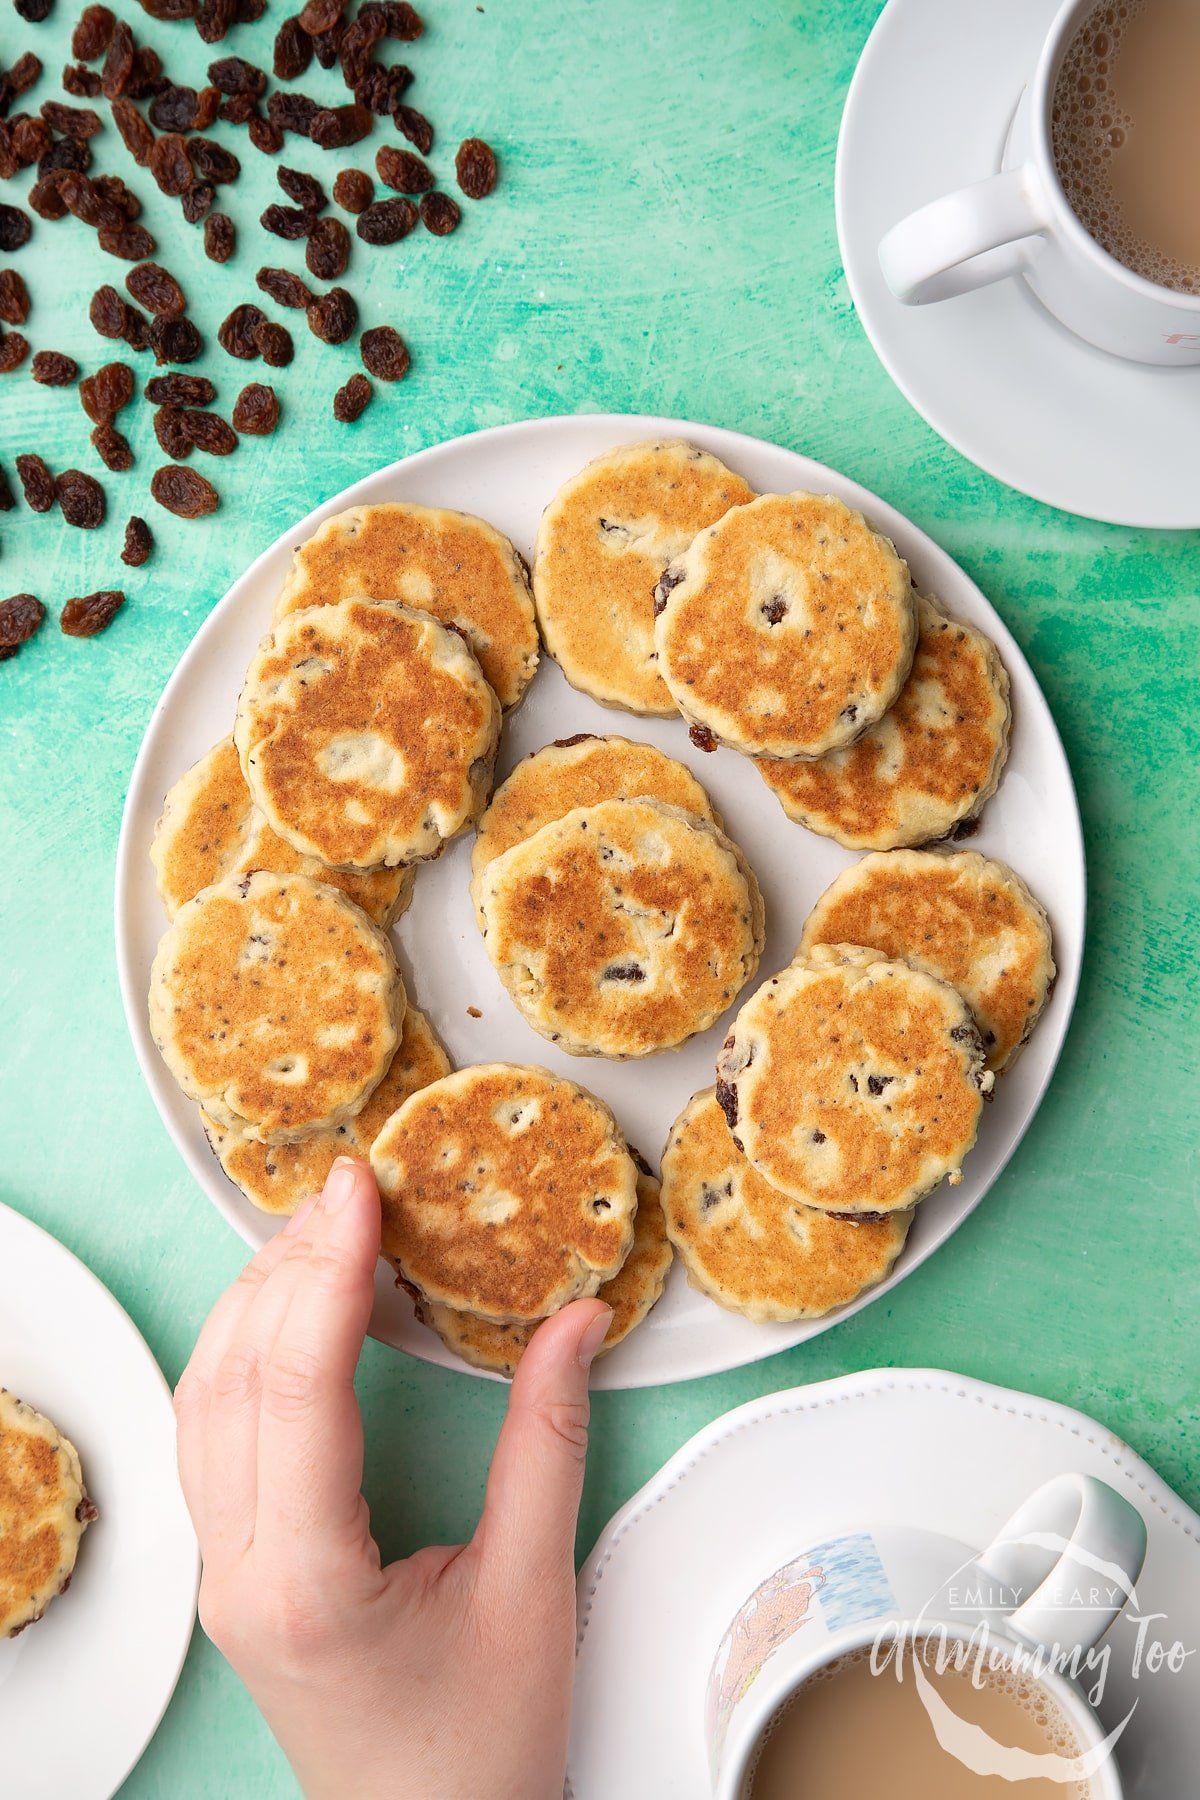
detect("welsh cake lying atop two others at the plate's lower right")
[716,945,993,1217]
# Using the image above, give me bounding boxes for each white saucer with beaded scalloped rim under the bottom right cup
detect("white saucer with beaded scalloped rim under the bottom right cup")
[567,1370,1200,1800]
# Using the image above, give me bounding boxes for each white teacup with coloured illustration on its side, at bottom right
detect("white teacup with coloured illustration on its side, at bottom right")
[703,1474,1146,1800]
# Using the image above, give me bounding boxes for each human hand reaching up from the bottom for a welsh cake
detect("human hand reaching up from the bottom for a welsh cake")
[175,1157,612,1800]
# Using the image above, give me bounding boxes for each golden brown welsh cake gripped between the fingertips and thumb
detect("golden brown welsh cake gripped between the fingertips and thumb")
[371,1062,637,1325]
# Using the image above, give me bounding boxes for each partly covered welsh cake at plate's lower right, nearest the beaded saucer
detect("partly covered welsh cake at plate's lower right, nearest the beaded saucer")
[662,1087,912,1321]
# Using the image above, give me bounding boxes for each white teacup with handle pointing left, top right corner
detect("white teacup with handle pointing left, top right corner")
[880,0,1200,367]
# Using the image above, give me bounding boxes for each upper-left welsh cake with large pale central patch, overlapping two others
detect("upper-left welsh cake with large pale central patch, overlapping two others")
[234,599,500,869]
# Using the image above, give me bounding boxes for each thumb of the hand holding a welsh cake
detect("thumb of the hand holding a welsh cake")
[475,1300,612,1593]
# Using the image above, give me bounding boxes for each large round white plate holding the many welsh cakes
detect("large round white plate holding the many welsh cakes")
[117,416,1085,1388]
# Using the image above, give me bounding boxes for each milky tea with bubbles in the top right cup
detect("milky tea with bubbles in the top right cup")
[1051,0,1200,293]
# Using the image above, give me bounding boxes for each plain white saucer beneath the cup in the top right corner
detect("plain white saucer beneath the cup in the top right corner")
[837,0,1200,529]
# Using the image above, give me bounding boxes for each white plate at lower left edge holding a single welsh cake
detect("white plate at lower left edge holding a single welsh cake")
[0,1206,200,1800]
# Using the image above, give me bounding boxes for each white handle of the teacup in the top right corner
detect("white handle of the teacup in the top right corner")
[880,162,1049,306]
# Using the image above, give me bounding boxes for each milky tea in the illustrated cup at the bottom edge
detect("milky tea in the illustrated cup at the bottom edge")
[745,1638,1094,1800]
